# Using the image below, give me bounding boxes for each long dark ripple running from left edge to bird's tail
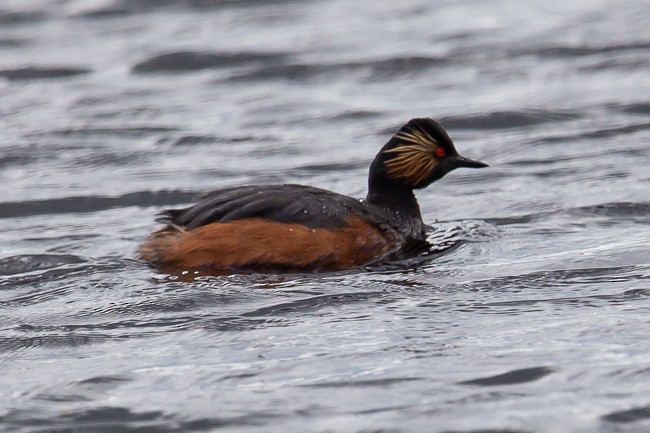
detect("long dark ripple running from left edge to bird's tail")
[0,190,198,218]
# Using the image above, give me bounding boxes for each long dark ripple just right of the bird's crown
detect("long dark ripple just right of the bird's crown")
[440,110,581,129]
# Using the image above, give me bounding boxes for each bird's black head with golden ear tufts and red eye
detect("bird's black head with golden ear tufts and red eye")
[368,118,488,191]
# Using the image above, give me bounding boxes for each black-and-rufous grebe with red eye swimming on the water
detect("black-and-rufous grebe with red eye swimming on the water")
[140,118,487,274]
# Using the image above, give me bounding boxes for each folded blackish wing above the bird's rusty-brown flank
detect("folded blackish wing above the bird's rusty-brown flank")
[160,185,364,230]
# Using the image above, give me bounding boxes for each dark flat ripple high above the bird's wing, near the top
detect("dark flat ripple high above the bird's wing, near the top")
[132,51,288,73]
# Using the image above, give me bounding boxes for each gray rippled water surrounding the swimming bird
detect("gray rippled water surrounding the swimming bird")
[0,0,650,433]
